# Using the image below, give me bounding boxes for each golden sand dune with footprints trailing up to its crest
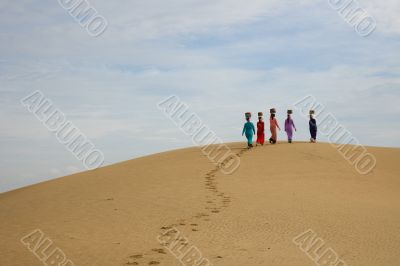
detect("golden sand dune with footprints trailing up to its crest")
[0,143,400,266]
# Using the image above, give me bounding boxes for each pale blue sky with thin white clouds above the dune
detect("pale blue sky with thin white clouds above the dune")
[0,0,400,191]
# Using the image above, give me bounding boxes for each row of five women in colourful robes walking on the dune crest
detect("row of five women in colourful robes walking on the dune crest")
[242,108,317,148]
